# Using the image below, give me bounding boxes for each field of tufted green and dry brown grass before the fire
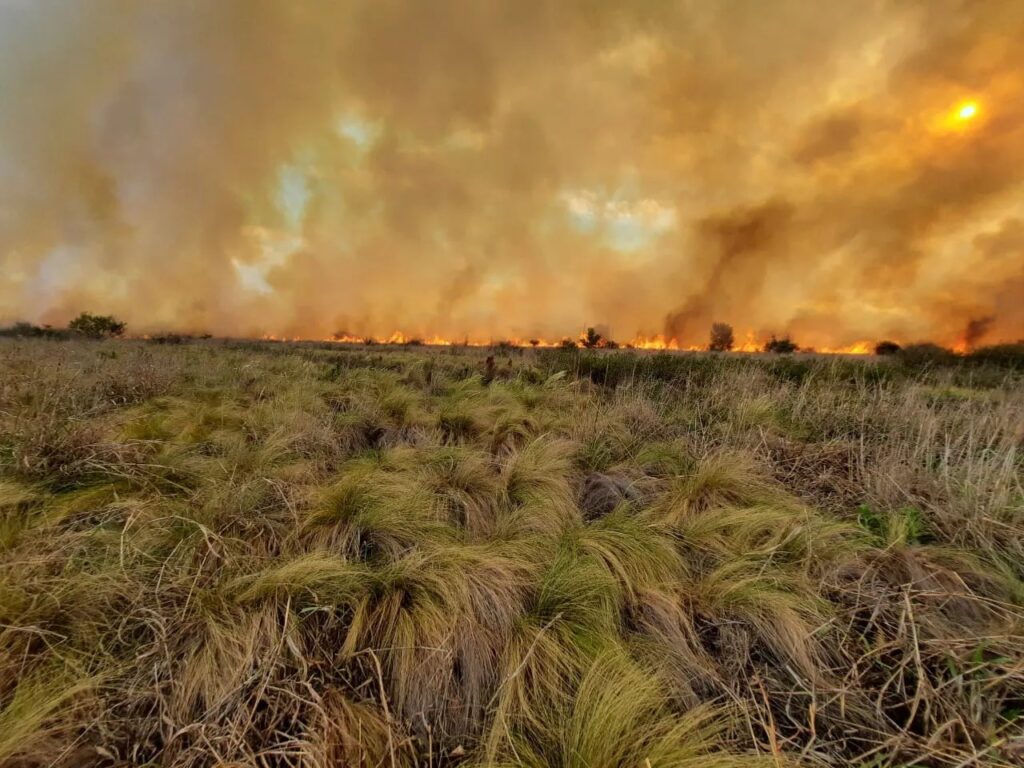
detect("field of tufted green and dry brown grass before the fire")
[0,340,1024,768]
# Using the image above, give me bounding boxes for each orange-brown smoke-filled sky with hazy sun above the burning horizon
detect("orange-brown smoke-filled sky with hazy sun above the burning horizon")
[0,0,1024,348]
